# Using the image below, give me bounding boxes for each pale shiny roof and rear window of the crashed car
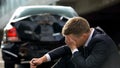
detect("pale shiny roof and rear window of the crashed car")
[14,5,78,18]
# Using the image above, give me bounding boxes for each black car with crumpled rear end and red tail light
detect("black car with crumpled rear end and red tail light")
[1,5,78,68]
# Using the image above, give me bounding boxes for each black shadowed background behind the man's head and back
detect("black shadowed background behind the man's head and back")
[80,3,120,45]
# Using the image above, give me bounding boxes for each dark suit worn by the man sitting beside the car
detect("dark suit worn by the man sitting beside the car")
[49,27,120,68]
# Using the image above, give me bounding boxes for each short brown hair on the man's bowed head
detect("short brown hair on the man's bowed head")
[62,17,90,36]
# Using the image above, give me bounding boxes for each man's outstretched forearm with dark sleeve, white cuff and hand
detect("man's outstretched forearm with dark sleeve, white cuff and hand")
[30,45,71,66]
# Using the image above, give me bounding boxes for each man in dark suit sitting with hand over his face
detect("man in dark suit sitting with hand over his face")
[30,17,120,68]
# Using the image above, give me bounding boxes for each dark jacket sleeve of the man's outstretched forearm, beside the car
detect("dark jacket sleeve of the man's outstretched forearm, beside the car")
[48,45,71,60]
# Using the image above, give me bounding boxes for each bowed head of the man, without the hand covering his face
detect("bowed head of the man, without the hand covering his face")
[62,17,90,46]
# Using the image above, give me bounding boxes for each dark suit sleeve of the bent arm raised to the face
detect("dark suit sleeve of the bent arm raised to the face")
[72,41,109,68]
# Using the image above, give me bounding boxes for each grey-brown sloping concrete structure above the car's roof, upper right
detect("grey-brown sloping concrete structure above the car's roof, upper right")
[57,0,120,14]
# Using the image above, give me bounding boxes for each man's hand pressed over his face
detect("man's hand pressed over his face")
[65,36,77,50]
